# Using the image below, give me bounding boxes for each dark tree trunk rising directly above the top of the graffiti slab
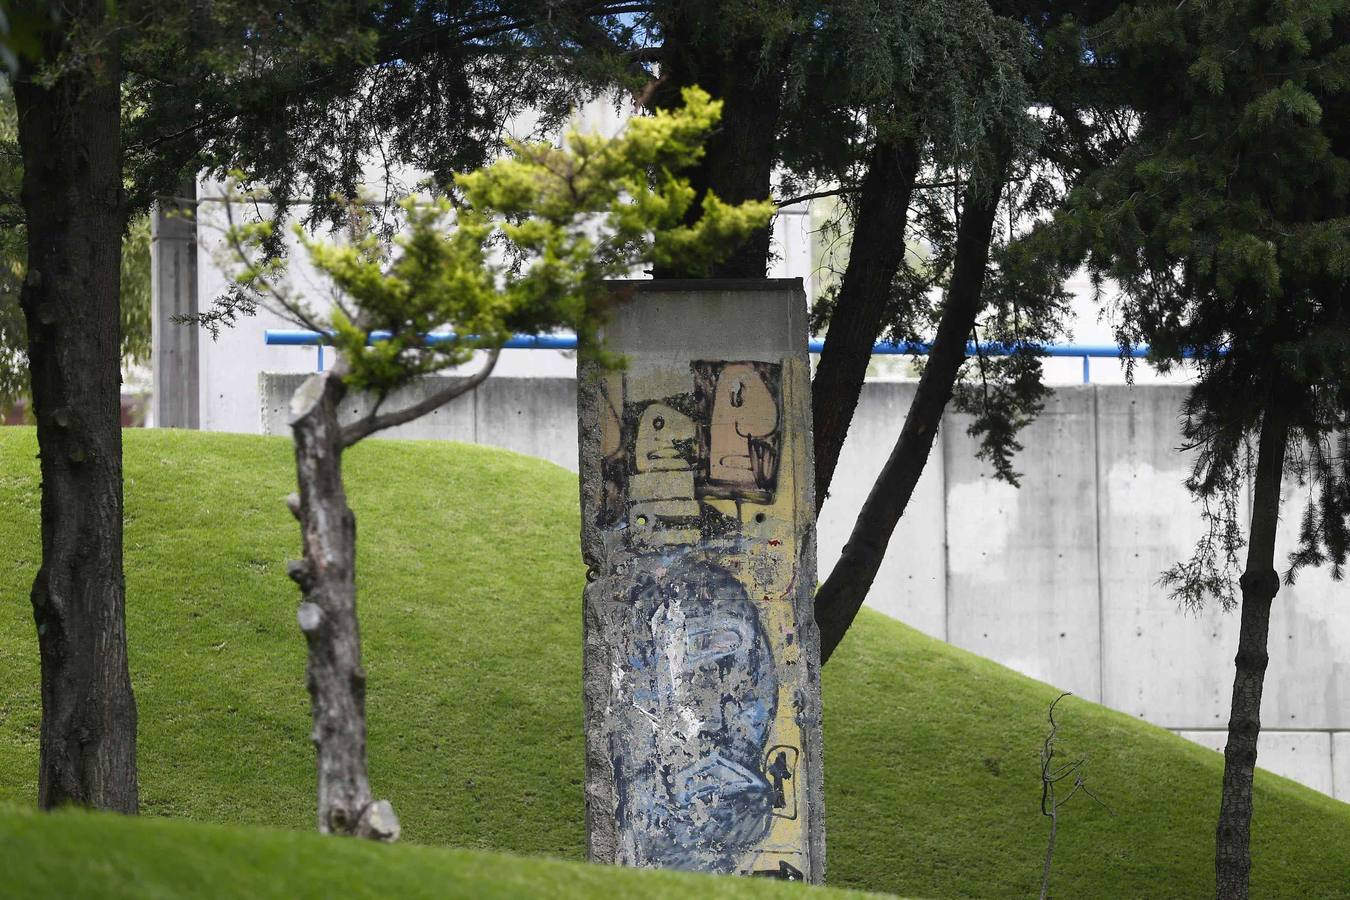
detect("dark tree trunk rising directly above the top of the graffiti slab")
[653,15,786,278]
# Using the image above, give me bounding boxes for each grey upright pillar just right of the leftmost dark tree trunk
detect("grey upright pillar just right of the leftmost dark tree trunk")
[150,179,201,428]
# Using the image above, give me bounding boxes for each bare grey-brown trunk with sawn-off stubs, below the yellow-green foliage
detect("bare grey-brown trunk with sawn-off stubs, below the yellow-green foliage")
[288,362,400,841]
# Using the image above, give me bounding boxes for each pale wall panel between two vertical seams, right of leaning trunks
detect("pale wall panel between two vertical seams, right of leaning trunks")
[944,387,1102,700]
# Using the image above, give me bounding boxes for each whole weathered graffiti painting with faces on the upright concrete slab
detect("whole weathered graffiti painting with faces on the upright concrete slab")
[595,360,805,877]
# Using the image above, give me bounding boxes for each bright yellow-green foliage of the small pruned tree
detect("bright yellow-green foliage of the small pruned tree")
[235,88,774,393]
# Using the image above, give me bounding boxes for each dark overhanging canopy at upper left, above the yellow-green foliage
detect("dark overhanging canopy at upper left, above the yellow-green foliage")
[127,0,642,220]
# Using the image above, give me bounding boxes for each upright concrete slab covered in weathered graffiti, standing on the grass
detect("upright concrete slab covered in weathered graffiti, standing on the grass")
[578,279,825,881]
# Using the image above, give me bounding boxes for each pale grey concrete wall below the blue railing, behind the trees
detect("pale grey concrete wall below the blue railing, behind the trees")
[259,375,1350,800]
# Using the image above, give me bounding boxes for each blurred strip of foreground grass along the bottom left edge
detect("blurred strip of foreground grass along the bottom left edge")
[0,807,867,900]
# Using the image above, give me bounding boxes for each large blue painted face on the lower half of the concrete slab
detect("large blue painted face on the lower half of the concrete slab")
[613,555,778,872]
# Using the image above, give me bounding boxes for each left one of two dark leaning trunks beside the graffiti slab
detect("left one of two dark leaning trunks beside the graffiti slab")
[811,142,919,513]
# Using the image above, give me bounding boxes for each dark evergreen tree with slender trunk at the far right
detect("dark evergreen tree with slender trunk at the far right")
[1046,0,1350,900]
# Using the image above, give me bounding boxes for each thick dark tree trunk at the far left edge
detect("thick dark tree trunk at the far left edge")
[14,0,138,812]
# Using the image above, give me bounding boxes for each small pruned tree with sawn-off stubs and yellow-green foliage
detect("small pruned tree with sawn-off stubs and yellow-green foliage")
[220,88,772,839]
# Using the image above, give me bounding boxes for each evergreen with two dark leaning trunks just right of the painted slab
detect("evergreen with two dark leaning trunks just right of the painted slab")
[793,0,1101,660]
